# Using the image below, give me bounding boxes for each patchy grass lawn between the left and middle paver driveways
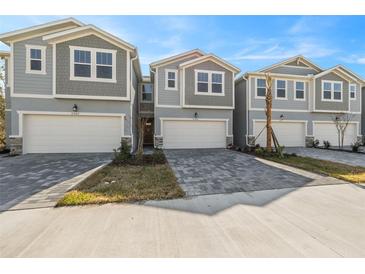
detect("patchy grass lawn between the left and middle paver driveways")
[57,163,185,206]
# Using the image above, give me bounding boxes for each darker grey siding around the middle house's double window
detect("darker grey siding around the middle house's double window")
[185,61,234,107]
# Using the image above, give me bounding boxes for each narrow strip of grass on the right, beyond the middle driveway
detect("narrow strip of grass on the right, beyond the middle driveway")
[264,155,365,183]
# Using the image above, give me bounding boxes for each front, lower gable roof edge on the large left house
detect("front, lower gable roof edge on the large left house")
[43,25,136,51]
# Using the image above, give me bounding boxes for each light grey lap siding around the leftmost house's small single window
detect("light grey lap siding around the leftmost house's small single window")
[13,37,53,95]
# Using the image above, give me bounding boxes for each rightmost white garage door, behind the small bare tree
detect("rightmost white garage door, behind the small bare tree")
[313,122,357,146]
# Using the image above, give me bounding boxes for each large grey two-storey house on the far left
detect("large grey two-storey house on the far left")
[0,18,142,154]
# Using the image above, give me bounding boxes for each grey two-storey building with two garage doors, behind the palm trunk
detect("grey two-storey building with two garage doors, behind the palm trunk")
[234,56,364,147]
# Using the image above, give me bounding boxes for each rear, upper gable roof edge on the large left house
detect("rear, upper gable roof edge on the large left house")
[0,17,84,44]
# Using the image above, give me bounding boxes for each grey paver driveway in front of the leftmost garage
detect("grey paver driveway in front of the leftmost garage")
[0,153,112,211]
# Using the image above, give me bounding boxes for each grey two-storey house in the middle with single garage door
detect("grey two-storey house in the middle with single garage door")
[150,49,239,149]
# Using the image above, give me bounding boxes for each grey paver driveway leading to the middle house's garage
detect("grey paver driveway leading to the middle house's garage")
[165,149,343,196]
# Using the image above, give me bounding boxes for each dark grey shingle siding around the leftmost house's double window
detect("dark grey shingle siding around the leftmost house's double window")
[56,35,129,97]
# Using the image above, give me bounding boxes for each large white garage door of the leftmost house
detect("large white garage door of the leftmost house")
[23,115,123,153]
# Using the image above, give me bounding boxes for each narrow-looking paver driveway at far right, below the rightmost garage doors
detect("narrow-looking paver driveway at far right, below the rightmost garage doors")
[285,147,365,167]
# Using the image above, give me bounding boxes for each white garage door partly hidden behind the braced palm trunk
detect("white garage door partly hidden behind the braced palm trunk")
[254,121,305,147]
